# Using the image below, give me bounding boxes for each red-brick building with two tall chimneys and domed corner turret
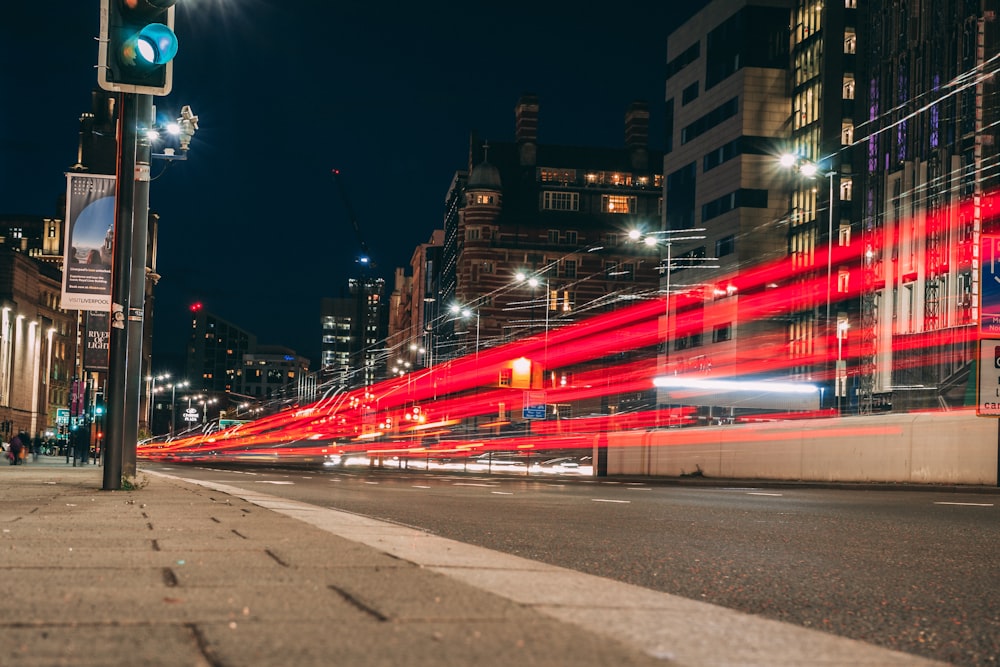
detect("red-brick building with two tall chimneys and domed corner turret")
[436,95,662,359]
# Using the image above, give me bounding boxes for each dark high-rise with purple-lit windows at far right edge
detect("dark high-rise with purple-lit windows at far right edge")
[860,0,1000,412]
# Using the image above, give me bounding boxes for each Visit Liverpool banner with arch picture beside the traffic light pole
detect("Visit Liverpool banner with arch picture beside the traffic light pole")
[61,174,115,312]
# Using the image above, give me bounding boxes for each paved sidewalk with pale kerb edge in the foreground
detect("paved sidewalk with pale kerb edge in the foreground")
[0,457,944,667]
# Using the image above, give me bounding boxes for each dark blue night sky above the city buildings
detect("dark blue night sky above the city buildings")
[0,0,705,371]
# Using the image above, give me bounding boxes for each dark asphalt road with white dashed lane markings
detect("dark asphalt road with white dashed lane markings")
[155,465,1000,665]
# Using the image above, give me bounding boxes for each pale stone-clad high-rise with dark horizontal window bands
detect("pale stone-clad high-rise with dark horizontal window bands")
[660,0,792,412]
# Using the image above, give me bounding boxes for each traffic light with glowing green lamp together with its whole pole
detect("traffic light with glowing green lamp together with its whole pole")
[97,0,177,490]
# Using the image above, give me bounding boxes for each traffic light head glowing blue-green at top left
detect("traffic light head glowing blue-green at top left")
[97,0,177,95]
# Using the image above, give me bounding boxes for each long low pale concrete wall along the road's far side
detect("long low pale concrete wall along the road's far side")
[607,411,998,486]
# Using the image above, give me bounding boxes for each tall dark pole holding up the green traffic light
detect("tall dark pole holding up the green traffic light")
[103,93,153,491]
